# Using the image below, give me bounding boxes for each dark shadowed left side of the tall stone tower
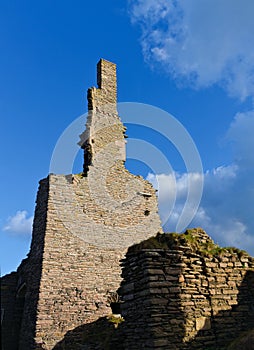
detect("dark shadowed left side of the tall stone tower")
[1,179,48,350]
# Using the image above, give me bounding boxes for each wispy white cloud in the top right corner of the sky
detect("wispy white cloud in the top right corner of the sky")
[129,0,254,99]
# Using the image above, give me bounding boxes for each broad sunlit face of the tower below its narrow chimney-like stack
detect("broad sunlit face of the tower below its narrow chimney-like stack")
[29,165,160,349]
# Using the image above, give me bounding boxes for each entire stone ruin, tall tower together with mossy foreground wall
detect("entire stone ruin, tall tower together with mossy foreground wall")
[1,60,254,350]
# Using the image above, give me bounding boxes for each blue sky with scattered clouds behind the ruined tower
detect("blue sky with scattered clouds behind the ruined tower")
[0,0,254,274]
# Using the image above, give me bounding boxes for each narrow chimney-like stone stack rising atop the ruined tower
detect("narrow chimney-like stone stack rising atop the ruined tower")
[80,60,125,175]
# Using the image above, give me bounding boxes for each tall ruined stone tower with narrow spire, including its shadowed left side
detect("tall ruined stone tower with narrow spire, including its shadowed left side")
[2,60,162,350]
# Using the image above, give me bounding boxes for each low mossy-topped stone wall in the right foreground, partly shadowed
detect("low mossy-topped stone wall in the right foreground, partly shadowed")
[120,229,254,350]
